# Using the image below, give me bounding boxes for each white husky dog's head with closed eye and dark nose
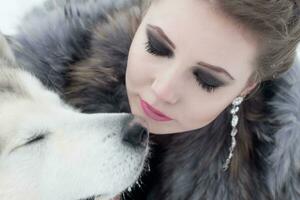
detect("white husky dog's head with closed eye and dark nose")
[0,35,148,200]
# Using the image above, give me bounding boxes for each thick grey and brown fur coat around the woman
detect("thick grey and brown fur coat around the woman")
[9,0,300,200]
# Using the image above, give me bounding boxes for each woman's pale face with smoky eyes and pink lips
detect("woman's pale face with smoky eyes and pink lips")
[126,0,257,134]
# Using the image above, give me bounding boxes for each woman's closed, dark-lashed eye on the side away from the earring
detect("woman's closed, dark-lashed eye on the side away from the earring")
[145,31,173,58]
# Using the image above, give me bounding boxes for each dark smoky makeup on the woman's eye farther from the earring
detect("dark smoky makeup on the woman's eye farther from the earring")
[145,26,174,58]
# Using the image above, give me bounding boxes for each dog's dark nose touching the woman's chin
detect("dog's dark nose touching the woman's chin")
[122,117,149,148]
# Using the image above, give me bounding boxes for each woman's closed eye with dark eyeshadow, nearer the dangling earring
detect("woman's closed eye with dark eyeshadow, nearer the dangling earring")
[194,70,224,92]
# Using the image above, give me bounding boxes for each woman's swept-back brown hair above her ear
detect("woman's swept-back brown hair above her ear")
[217,0,300,82]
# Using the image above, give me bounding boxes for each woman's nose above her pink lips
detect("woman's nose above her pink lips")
[151,70,180,104]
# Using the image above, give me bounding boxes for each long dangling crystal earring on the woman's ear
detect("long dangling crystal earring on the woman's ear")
[223,96,244,171]
